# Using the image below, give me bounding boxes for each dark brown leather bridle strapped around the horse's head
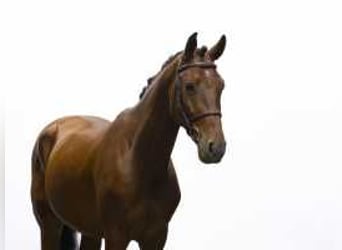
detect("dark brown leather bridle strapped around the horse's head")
[175,62,222,142]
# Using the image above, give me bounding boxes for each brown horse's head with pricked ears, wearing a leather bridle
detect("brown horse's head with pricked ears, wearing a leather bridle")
[170,33,226,163]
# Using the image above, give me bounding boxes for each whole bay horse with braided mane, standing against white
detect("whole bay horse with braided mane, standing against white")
[31,33,226,250]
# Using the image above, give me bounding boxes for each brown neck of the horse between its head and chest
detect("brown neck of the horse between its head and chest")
[132,60,179,176]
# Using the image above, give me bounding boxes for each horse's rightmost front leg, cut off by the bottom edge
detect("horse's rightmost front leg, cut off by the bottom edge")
[139,226,167,250]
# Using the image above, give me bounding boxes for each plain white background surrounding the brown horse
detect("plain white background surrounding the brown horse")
[1,0,342,250]
